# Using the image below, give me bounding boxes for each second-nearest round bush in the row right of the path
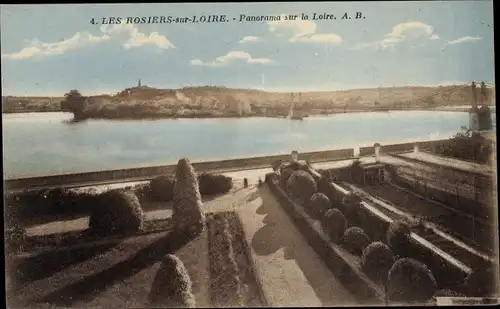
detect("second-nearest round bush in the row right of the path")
[361,241,395,283]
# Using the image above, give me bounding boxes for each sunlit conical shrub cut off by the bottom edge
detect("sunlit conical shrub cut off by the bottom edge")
[149,254,196,308]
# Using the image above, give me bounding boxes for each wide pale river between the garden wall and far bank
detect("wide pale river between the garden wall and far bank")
[3,111,468,178]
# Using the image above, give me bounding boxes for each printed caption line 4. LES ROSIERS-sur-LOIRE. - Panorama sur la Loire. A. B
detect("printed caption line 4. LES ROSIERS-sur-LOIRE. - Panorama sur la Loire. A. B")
[90,12,366,25]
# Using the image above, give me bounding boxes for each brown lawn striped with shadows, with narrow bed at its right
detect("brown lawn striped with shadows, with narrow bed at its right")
[7,212,263,308]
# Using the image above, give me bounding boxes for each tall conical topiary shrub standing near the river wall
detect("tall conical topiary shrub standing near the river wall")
[172,158,206,235]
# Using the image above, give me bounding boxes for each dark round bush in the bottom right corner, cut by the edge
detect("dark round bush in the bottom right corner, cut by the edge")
[464,266,498,297]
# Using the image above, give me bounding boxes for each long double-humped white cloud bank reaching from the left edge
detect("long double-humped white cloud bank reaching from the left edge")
[2,24,175,60]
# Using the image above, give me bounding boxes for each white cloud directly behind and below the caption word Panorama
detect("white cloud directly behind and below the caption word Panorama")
[267,14,342,44]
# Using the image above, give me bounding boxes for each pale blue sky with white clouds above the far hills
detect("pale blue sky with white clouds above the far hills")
[1,1,494,95]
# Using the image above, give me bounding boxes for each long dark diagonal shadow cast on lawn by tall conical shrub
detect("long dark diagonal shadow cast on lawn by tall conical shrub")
[37,232,192,307]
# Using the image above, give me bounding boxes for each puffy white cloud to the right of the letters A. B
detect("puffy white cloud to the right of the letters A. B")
[351,21,440,50]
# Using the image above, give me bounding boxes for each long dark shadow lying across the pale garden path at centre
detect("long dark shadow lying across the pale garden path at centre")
[252,186,353,306]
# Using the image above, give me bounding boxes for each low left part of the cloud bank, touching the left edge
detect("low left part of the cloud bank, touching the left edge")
[2,32,110,60]
